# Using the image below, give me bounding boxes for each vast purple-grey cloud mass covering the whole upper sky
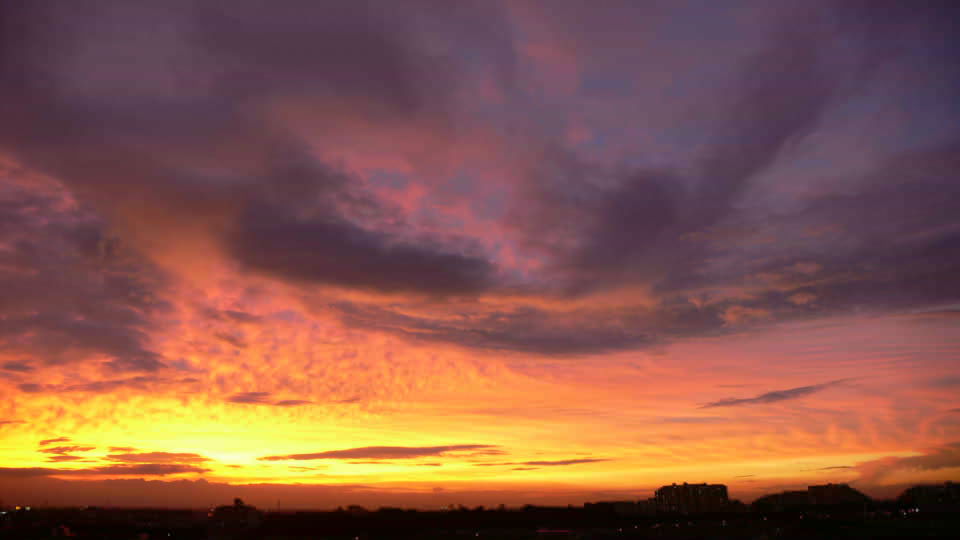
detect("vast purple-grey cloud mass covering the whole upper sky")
[0,2,960,364]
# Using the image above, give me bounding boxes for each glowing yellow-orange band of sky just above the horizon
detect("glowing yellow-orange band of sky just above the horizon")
[2,270,956,504]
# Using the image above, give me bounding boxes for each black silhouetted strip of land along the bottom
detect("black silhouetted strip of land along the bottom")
[0,507,960,540]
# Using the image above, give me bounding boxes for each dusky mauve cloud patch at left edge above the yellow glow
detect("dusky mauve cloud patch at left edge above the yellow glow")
[0,176,164,374]
